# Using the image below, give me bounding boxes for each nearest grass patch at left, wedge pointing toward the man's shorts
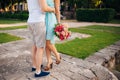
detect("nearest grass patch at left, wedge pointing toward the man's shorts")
[0,33,22,44]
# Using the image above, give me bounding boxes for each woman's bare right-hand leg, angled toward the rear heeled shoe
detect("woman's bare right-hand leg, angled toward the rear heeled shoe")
[46,40,60,61]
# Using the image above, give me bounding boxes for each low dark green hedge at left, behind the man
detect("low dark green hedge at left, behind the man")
[0,11,28,20]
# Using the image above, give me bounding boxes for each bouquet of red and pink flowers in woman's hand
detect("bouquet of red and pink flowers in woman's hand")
[54,23,71,40]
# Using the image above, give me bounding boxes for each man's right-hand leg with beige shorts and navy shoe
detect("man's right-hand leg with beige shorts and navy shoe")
[34,23,49,77]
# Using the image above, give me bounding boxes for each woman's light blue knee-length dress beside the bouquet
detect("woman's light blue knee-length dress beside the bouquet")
[45,0,57,44]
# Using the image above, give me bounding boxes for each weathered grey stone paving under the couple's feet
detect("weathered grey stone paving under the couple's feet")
[0,23,120,80]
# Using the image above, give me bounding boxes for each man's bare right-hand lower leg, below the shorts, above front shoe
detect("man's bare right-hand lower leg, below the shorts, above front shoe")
[36,48,44,72]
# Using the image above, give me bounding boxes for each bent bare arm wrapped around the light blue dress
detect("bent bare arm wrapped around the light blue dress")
[39,0,55,12]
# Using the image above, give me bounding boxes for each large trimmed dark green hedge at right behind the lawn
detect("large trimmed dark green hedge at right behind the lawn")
[76,8,115,22]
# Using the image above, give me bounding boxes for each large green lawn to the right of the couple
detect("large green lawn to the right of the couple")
[56,25,120,59]
